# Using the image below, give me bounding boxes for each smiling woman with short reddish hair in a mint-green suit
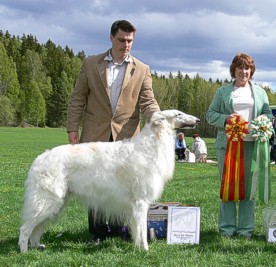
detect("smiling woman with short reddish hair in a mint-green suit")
[206,53,272,239]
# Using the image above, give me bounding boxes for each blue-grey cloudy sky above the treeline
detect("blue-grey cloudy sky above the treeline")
[0,0,276,91]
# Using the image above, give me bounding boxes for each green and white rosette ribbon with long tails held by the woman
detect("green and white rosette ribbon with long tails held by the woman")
[246,115,274,203]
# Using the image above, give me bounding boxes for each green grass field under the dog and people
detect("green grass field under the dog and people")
[0,128,276,267]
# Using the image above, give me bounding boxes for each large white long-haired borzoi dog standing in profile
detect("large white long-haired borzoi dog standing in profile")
[19,110,199,252]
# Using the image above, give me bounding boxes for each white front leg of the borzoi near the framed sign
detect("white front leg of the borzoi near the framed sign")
[130,201,148,251]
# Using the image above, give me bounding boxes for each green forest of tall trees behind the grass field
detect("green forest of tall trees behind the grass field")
[0,31,276,137]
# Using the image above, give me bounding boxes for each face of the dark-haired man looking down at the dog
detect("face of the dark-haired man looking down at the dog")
[110,29,134,59]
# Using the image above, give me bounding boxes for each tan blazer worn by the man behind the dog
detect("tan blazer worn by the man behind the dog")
[67,51,160,142]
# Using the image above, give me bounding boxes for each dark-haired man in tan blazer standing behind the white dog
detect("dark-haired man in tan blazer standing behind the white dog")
[67,20,160,243]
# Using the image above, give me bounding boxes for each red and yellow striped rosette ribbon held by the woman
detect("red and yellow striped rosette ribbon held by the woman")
[220,116,249,202]
